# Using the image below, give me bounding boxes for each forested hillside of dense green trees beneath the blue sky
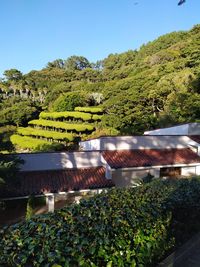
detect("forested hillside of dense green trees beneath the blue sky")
[0,25,200,137]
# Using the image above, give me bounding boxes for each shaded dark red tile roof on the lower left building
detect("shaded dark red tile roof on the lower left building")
[0,167,114,197]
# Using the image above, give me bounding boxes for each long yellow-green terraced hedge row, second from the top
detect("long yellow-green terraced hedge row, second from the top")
[40,111,102,121]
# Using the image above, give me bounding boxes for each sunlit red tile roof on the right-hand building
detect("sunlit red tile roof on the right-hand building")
[103,148,200,169]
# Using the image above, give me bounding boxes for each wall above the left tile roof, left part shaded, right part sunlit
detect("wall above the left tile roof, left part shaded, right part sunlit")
[18,151,102,171]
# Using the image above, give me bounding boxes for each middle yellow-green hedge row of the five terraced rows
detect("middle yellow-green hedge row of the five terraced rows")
[28,119,95,132]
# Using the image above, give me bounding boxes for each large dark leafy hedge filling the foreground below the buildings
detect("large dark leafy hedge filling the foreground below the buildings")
[0,179,200,267]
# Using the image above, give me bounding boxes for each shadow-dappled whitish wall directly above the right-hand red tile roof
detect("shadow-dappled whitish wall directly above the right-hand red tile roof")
[80,135,199,151]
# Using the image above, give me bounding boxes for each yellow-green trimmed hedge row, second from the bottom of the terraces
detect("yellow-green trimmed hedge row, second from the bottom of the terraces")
[17,127,75,142]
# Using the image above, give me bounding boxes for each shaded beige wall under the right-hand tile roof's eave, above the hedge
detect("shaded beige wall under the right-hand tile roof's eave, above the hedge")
[112,169,160,187]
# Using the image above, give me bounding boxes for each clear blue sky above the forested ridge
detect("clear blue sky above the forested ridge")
[0,0,200,77]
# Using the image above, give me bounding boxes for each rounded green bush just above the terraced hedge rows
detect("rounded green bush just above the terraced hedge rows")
[53,92,86,111]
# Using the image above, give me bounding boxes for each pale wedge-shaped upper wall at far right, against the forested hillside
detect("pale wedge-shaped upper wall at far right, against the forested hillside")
[144,122,200,135]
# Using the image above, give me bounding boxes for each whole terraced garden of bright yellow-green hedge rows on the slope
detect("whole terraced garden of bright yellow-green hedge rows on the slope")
[10,107,103,151]
